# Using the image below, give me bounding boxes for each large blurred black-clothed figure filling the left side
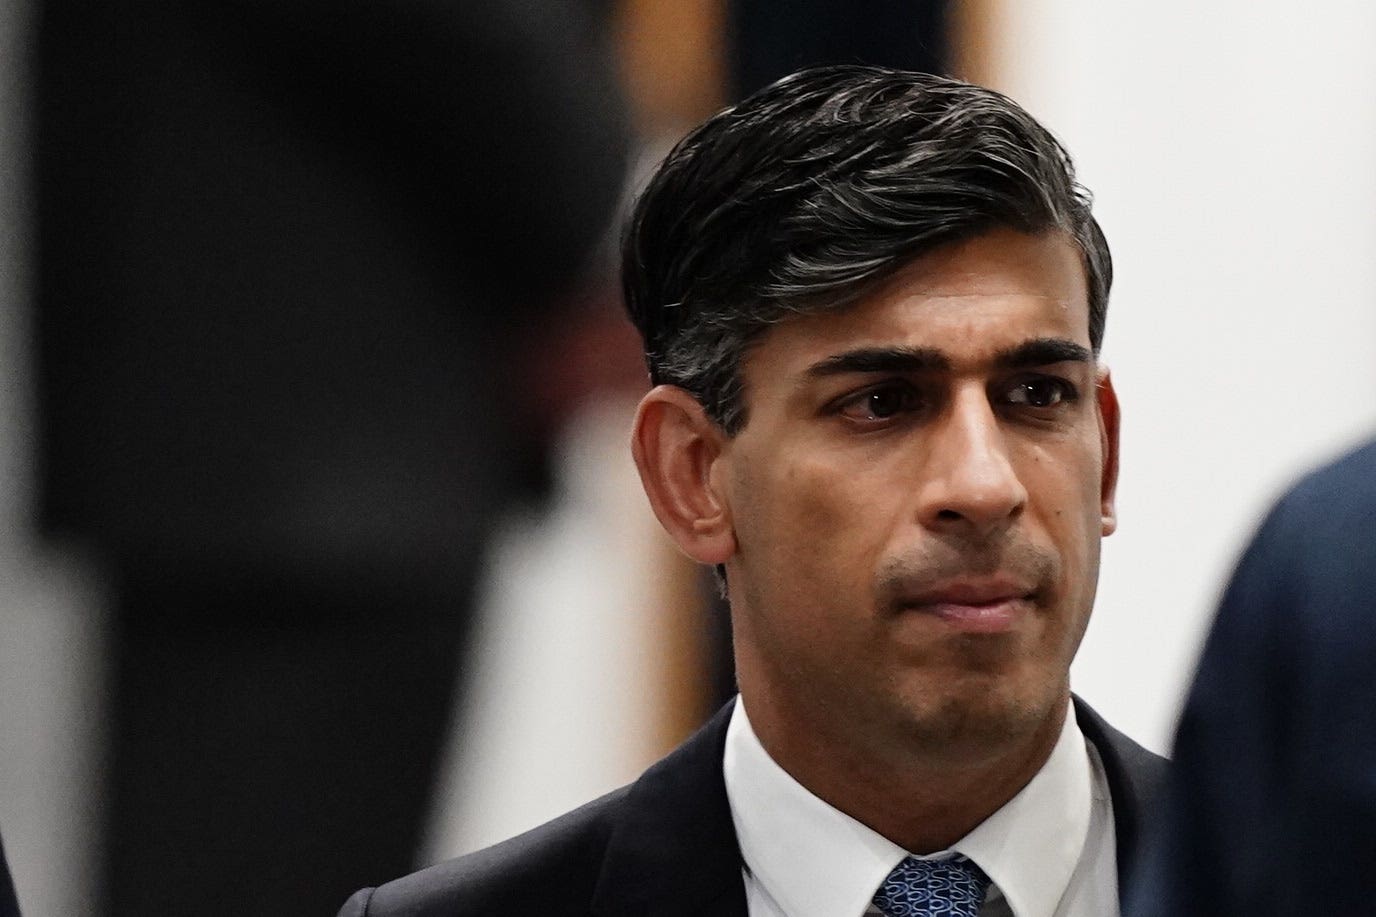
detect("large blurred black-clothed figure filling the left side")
[36,0,625,917]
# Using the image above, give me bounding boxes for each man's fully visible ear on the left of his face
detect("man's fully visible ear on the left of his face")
[630,386,736,565]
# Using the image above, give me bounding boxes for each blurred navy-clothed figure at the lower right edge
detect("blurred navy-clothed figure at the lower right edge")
[1128,443,1376,917]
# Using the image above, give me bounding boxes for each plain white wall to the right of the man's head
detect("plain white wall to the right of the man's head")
[998,0,1376,749]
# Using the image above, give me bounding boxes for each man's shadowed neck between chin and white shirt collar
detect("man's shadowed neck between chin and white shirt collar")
[742,684,1069,854]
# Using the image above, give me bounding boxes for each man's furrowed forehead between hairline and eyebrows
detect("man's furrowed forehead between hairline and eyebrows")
[746,230,1090,374]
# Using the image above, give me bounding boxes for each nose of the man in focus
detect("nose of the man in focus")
[918,388,1028,538]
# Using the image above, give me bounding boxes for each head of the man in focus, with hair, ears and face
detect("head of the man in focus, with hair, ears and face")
[625,67,1117,787]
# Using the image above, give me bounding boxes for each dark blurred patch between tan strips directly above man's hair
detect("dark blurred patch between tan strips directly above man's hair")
[728,0,951,101]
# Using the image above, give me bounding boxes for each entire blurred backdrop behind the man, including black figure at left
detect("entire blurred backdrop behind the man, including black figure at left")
[0,0,1376,917]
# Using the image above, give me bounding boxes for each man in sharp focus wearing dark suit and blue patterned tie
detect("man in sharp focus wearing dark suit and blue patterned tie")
[341,66,1164,917]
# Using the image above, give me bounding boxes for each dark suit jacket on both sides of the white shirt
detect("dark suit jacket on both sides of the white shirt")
[340,699,1165,917]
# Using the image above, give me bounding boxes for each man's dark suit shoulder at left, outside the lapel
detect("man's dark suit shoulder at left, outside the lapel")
[340,788,629,917]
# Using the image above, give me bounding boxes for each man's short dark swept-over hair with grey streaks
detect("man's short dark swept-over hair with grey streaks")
[622,65,1113,435]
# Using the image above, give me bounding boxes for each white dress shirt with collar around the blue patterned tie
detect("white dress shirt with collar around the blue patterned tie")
[722,698,1119,917]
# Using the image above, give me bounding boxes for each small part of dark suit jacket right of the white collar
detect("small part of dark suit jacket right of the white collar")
[1075,698,1167,905]
